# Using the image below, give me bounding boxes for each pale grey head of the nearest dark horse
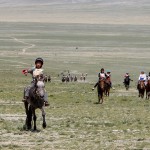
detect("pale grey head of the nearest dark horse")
[35,77,45,99]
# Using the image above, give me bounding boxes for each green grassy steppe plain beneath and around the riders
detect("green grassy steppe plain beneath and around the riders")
[0,23,150,150]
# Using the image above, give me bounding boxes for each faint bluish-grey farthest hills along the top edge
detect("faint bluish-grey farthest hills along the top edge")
[0,0,150,7]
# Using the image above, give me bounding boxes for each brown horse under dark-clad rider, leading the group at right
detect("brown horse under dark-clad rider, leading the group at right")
[97,79,105,104]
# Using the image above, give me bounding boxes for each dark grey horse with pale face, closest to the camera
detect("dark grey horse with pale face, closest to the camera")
[24,77,46,130]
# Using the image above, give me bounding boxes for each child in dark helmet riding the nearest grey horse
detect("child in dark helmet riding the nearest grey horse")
[22,58,49,106]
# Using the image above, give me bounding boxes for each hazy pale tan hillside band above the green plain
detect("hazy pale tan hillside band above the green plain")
[0,0,150,25]
